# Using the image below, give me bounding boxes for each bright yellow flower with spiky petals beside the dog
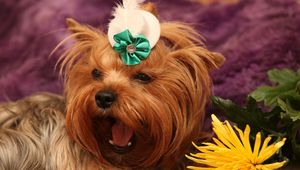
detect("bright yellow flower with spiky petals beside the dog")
[187,115,286,170]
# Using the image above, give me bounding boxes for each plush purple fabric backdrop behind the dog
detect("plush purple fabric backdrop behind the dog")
[0,0,300,103]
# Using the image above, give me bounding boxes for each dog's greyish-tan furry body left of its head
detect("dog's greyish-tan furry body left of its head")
[0,93,103,170]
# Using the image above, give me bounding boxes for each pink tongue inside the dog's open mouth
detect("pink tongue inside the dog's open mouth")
[112,121,133,147]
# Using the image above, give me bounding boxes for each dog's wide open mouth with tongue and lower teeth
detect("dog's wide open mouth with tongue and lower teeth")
[108,120,136,154]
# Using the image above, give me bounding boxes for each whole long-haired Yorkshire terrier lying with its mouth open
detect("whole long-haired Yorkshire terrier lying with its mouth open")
[0,0,224,170]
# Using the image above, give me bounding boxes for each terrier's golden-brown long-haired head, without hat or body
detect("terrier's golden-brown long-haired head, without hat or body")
[61,5,223,168]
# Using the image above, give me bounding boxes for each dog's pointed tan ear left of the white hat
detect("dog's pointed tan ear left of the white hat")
[66,18,103,41]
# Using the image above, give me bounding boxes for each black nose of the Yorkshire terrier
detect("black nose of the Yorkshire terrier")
[95,91,117,109]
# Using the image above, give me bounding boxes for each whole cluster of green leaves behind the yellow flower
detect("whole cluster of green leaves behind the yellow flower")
[212,69,300,162]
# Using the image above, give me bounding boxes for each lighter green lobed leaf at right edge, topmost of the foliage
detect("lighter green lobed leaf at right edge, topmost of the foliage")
[250,69,300,107]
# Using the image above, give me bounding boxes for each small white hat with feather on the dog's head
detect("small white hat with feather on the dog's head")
[107,0,160,48]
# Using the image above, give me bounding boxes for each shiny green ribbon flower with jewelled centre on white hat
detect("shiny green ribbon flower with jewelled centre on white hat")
[113,29,151,65]
